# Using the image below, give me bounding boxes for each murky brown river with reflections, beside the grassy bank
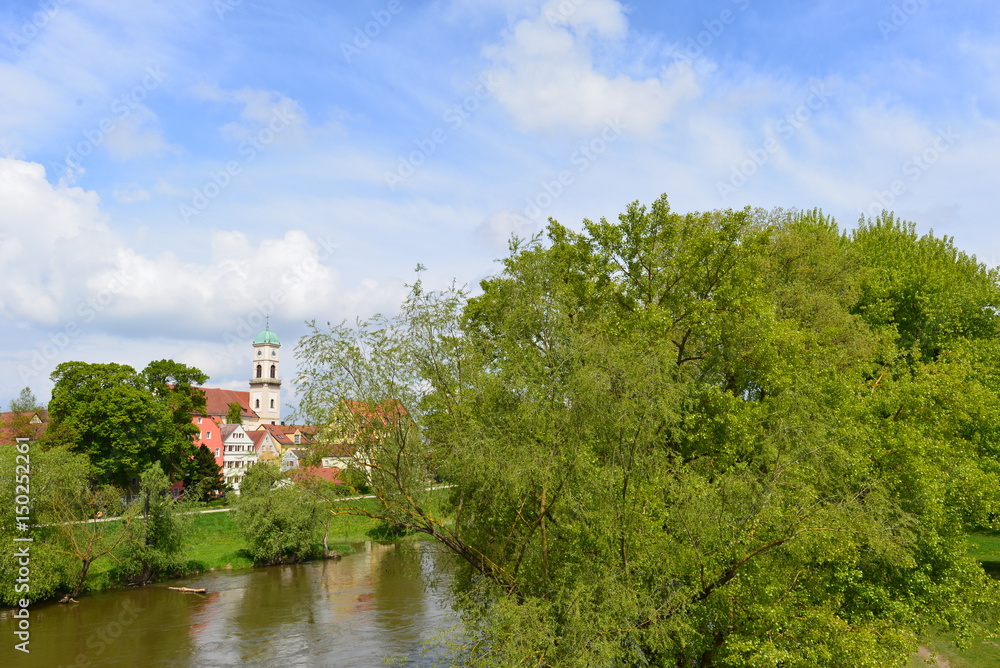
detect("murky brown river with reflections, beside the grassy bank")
[0,542,455,668]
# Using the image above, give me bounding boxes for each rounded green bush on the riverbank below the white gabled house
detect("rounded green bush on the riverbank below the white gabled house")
[235,462,319,564]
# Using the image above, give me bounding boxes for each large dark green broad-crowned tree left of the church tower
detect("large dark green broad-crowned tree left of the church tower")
[46,360,205,487]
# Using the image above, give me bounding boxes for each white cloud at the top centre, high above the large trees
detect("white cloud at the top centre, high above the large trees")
[486,0,700,135]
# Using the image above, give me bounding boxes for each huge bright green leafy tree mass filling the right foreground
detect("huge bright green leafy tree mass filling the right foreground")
[298,198,1000,666]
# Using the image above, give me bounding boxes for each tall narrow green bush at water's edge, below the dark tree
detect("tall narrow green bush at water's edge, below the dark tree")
[117,463,191,584]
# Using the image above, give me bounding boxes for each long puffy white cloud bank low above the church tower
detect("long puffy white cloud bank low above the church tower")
[0,158,401,338]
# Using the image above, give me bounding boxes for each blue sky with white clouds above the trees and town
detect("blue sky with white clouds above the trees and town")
[0,0,1000,408]
